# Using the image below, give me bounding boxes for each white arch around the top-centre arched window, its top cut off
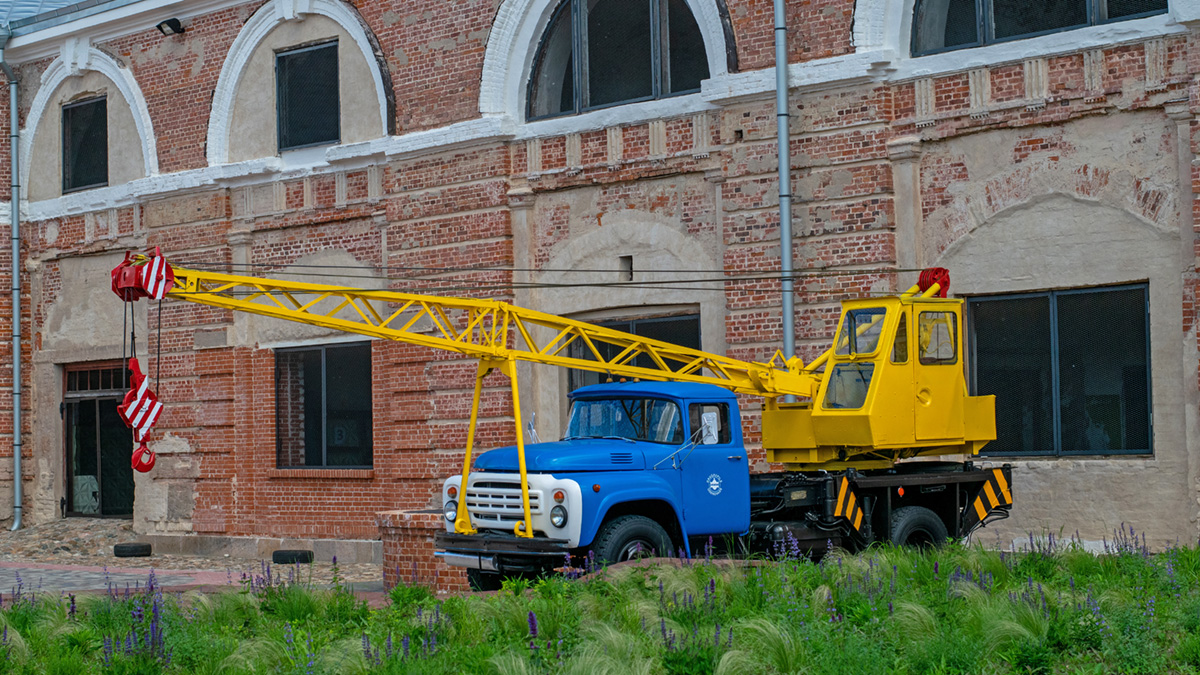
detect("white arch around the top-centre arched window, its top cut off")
[479,0,728,121]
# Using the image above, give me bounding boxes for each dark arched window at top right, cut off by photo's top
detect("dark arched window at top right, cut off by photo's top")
[912,0,1168,56]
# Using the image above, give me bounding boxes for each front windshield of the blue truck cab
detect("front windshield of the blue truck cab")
[564,399,683,443]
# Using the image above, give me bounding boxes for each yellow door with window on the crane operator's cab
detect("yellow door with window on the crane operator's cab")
[913,303,965,441]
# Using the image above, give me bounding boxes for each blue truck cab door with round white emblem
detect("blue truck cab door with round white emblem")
[679,402,750,536]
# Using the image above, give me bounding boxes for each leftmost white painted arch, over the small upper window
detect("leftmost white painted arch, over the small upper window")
[20,41,158,199]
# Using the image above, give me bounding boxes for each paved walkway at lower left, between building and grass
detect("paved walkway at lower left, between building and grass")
[0,562,388,607]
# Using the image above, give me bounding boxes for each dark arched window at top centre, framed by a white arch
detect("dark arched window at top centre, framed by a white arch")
[527,0,708,119]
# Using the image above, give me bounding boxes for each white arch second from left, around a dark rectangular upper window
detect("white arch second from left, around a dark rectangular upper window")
[208,0,389,166]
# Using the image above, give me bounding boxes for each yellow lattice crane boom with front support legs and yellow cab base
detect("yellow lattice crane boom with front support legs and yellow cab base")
[133,256,995,537]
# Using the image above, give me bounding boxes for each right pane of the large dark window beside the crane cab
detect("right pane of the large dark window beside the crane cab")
[1057,288,1150,453]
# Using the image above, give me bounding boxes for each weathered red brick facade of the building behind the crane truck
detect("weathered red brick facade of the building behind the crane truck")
[0,0,1200,580]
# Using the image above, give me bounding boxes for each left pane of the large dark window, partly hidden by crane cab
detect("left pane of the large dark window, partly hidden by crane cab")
[971,295,1054,454]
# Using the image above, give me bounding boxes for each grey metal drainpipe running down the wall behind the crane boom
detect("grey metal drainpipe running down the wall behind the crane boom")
[775,0,796,402]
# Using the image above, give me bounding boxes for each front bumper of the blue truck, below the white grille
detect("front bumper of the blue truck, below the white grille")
[433,532,571,572]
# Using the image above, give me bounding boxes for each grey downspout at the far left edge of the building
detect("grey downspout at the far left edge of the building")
[0,25,22,532]
